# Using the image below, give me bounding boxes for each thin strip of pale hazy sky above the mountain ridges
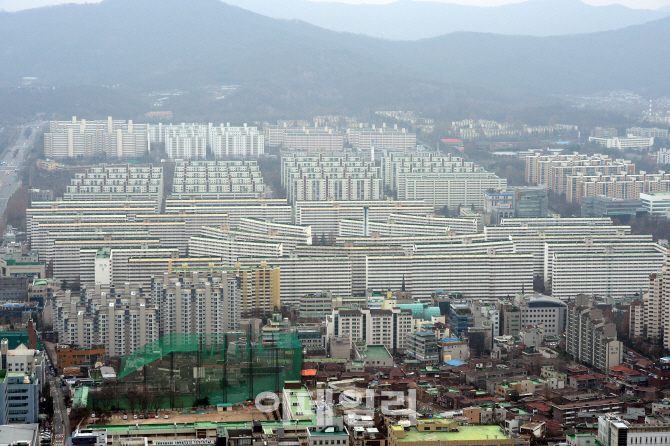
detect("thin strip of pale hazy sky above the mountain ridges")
[0,0,670,11]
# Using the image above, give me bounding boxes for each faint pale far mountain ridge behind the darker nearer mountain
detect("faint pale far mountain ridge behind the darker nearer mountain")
[222,0,670,40]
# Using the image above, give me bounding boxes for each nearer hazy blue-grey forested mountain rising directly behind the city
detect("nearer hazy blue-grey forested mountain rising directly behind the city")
[0,0,670,114]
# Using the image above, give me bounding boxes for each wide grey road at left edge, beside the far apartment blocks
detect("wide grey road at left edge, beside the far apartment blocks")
[0,121,43,216]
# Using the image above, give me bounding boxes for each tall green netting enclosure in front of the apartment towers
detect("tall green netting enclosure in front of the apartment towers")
[119,332,302,408]
